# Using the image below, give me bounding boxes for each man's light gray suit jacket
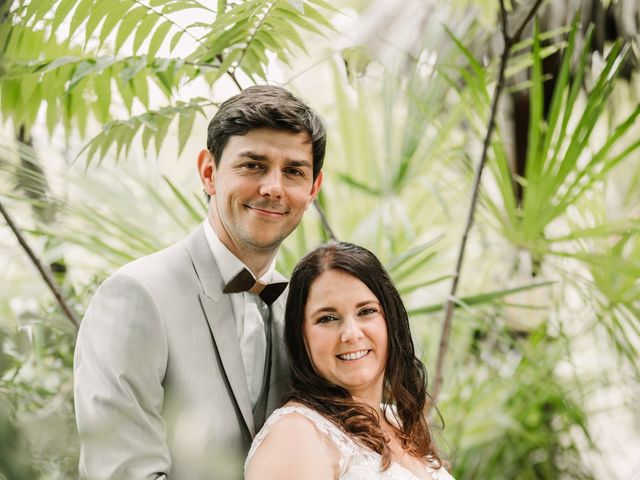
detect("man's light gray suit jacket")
[74,226,288,480]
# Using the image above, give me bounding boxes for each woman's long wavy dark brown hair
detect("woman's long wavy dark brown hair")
[285,242,442,470]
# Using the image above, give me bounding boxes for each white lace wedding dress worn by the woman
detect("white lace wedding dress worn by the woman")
[245,405,453,480]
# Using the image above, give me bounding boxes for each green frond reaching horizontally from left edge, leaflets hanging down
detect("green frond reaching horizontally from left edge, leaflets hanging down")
[0,55,202,135]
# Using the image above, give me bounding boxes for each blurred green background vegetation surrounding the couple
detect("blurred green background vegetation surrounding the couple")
[0,0,640,479]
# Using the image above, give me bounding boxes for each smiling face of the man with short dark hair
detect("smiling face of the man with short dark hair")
[199,128,322,260]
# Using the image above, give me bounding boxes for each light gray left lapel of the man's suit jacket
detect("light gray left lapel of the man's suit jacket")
[186,226,255,437]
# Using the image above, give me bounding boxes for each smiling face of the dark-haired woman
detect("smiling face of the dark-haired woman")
[302,270,387,402]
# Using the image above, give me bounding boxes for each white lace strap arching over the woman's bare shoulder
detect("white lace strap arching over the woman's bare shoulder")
[245,405,356,475]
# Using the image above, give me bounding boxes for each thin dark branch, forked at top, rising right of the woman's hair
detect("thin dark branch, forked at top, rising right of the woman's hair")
[432,0,543,401]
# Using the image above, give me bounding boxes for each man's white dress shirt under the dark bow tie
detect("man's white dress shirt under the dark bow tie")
[204,219,276,407]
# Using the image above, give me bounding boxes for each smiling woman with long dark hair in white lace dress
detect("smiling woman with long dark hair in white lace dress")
[245,242,452,480]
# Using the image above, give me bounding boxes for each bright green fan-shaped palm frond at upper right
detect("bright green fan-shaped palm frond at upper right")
[483,18,640,254]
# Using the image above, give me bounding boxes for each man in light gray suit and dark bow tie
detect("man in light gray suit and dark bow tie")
[75,86,326,480]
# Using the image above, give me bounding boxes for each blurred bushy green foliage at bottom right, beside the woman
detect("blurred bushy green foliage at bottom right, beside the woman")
[440,331,594,480]
